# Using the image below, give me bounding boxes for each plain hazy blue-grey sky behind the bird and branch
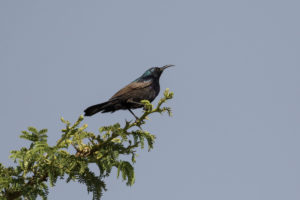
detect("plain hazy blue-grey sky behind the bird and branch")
[0,0,300,200]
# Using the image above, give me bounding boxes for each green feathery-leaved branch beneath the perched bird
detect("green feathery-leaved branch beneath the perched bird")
[0,89,173,200]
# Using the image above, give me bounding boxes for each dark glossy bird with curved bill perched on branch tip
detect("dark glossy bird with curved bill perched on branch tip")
[84,65,174,118]
